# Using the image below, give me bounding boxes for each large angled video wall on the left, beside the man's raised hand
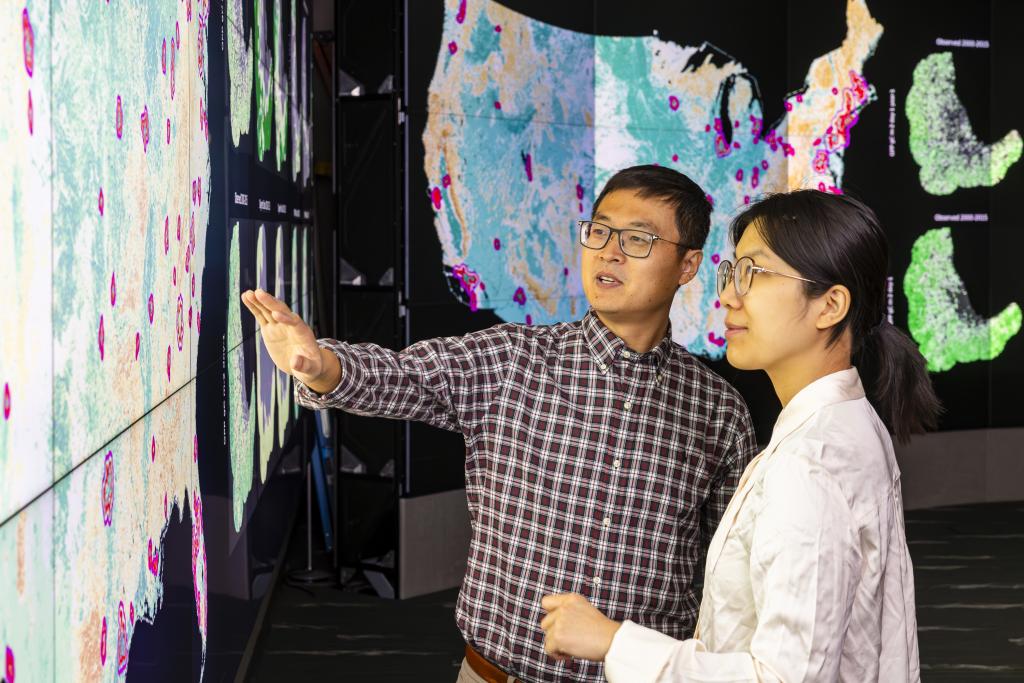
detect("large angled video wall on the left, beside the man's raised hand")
[0,0,310,683]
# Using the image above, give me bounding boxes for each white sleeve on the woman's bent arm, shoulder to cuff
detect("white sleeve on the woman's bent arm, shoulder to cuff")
[605,453,860,683]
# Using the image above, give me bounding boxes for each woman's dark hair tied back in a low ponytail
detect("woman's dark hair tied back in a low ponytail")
[731,189,941,442]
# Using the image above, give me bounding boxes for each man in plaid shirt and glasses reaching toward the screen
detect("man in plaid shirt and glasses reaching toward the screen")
[243,166,755,683]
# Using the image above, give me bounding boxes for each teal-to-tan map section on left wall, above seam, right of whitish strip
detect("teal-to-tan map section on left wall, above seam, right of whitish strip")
[52,0,210,477]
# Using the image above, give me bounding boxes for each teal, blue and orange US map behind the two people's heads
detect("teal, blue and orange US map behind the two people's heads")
[423,0,883,357]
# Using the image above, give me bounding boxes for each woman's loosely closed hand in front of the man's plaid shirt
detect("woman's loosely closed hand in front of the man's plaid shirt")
[541,593,622,661]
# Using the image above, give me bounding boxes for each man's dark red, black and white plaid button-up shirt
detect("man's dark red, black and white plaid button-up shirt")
[296,311,756,683]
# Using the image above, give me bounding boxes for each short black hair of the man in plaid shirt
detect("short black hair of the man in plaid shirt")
[594,164,711,253]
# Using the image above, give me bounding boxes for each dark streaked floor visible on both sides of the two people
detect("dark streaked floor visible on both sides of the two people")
[248,502,1024,683]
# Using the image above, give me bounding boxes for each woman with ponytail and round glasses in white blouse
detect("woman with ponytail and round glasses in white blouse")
[541,190,939,683]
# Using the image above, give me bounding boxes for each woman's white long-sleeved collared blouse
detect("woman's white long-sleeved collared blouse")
[604,368,921,683]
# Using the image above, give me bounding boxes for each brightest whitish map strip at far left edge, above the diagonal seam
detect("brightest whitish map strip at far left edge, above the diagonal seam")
[0,2,53,524]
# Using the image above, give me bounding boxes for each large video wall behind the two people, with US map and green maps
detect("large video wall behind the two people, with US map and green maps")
[410,0,1024,428]
